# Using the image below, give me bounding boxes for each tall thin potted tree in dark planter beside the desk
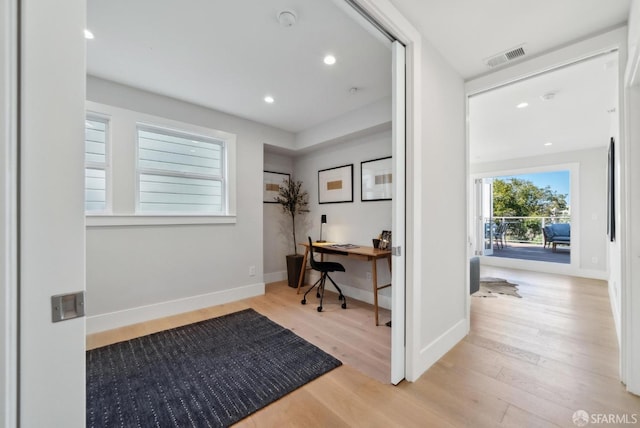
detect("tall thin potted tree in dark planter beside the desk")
[276,178,309,288]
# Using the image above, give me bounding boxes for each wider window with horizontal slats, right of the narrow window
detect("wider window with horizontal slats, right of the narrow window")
[137,124,226,215]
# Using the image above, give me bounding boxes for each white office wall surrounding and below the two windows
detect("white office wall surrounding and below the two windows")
[87,77,293,332]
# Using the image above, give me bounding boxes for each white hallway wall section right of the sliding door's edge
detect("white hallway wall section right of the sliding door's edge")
[407,40,469,370]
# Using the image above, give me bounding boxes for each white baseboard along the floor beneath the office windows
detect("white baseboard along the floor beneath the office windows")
[86,283,264,334]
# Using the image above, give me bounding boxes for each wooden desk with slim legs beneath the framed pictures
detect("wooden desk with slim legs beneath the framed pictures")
[296,242,391,325]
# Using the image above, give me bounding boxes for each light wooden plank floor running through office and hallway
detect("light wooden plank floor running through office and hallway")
[87,267,640,427]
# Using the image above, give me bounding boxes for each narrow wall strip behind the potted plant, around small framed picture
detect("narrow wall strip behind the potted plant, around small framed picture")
[263,150,302,283]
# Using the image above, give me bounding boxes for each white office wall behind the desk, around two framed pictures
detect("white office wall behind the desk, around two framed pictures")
[294,131,391,308]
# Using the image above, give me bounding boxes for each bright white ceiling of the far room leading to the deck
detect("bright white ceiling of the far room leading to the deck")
[469,52,618,163]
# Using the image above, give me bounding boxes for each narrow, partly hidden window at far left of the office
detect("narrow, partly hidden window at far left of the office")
[84,116,109,213]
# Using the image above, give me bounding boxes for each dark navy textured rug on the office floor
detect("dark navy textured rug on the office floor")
[86,309,342,428]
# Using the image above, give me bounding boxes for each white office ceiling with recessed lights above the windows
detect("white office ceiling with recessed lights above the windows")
[87,0,391,133]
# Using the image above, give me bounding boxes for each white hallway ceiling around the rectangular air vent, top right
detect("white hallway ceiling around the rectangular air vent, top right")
[391,0,630,80]
